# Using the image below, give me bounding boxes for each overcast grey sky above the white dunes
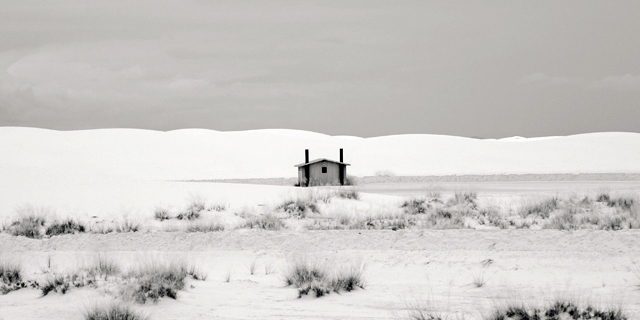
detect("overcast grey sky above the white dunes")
[0,0,640,138]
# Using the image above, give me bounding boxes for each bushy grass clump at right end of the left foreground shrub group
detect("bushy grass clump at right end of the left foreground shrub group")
[121,261,189,304]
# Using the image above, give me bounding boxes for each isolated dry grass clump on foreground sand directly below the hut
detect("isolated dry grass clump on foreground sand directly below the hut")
[283,258,365,298]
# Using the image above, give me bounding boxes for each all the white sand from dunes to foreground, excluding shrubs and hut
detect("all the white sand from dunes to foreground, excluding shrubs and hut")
[0,127,640,320]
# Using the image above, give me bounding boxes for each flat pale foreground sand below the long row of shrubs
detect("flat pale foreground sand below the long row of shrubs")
[0,230,640,320]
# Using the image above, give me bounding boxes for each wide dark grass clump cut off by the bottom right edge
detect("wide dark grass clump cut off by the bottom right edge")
[484,300,629,320]
